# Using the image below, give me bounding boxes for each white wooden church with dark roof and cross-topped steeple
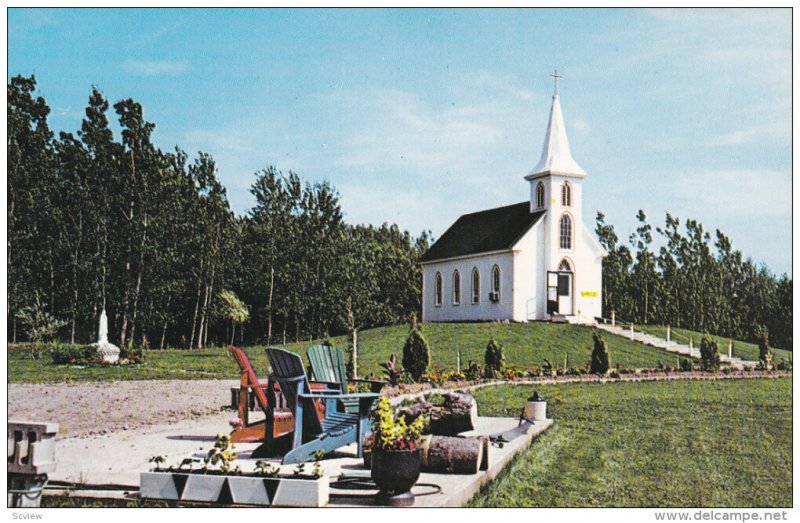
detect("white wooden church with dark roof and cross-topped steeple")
[421,71,607,323]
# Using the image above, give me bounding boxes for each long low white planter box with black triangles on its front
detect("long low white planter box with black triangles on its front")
[139,472,330,507]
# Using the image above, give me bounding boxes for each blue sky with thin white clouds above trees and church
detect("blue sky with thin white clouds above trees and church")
[8,9,792,274]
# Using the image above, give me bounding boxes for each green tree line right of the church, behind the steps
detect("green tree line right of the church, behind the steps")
[595,210,792,350]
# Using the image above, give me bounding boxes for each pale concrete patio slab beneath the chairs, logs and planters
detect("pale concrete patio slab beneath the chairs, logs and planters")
[50,412,553,507]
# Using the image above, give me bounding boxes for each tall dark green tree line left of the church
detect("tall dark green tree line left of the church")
[7,76,430,348]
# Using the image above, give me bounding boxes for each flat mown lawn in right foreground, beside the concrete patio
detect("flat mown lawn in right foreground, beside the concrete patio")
[469,378,792,507]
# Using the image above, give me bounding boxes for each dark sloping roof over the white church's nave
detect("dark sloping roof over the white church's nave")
[420,201,545,262]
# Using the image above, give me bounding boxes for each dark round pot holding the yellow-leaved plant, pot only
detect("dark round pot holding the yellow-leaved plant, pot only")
[372,448,422,505]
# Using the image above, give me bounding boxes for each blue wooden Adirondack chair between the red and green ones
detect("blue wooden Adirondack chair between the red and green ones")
[266,348,380,464]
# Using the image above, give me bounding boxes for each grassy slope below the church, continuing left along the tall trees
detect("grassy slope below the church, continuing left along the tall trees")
[8,323,677,383]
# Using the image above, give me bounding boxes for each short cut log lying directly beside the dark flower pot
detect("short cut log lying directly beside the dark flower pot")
[422,436,485,474]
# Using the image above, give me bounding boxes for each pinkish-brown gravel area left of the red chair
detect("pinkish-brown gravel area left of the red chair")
[8,380,239,439]
